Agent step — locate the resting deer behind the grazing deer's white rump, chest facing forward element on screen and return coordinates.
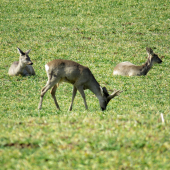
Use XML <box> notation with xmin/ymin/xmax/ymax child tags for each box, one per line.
<box><xmin>8</xmin><ymin>48</ymin><xmax>35</xmax><ymax>76</ymax></box>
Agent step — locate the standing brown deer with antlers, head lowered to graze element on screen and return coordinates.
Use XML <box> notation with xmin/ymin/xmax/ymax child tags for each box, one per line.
<box><xmin>38</xmin><ymin>59</ymin><xmax>122</xmax><ymax>111</ymax></box>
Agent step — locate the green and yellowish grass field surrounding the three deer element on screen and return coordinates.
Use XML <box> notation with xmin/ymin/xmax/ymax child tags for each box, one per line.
<box><xmin>0</xmin><ymin>0</ymin><xmax>170</xmax><ymax>170</ymax></box>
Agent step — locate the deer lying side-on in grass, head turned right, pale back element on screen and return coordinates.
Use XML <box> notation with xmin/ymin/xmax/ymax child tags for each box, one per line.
<box><xmin>113</xmin><ymin>48</ymin><xmax>162</xmax><ymax>76</ymax></box>
